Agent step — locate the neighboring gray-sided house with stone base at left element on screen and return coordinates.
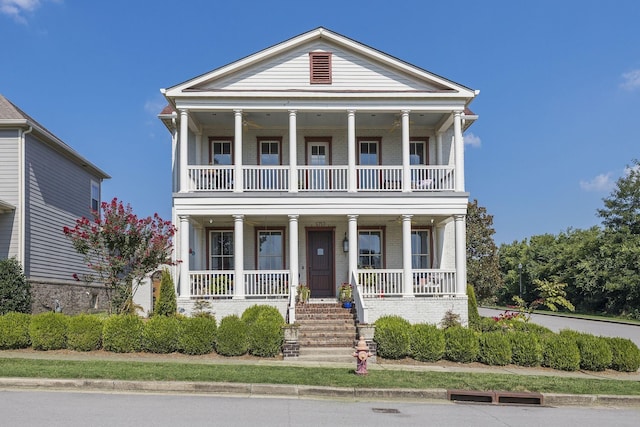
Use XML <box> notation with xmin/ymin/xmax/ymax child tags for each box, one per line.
<box><xmin>0</xmin><ymin>95</ymin><xmax>110</xmax><ymax>312</ymax></box>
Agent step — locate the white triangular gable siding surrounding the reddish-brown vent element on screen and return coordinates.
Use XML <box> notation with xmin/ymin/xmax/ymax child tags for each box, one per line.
<box><xmin>203</xmin><ymin>41</ymin><xmax>439</xmax><ymax>91</ymax></box>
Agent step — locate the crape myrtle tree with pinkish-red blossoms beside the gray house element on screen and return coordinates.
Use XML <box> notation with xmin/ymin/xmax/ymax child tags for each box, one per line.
<box><xmin>63</xmin><ymin>198</ymin><xmax>175</xmax><ymax>313</ymax></box>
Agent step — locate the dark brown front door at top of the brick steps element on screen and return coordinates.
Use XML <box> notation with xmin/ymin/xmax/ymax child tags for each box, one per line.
<box><xmin>307</xmin><ymin>230</ymin><xmax>336</xmax><ymax>298</ymax></box>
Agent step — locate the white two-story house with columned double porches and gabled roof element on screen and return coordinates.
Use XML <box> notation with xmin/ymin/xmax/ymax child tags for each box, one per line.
<box><xmin>159</xmin><ymin>28</ymin><xmax>478</xmax><ymax>323</ymax></box>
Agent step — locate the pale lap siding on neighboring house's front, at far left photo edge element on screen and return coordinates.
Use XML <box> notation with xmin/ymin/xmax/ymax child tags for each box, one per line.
<box><xmin>0</xmin><ymin>135</ymin><xmax>19</xmax><ymax>259</ymax></box>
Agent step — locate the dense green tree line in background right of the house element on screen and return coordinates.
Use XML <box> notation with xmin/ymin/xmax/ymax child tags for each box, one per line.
<box><xmin>467</xmin><ymin>160</ymin><xmax>640</xmax><ymax>319</ymax></box>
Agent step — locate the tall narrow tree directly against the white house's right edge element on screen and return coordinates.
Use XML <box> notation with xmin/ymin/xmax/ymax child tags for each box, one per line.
<box><xmin>466</xmin><ymin>200</ymin><xmax>503</xmax><ymax>302</ymax></box>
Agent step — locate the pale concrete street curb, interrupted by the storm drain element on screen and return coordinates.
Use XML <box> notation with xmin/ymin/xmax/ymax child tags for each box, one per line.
<box><xmin>0</xmin><ymin>378</ymin><xmax>640</xmax><ymax>407</ymax></box>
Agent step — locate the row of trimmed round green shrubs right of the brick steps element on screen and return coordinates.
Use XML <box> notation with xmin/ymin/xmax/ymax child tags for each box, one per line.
<box><xmin>374</xmin><ymin>316</ymin><xmax>640</xmax><ymax>372</ymax></box>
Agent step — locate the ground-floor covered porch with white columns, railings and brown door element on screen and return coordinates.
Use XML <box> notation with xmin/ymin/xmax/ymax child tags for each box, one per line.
<box><xmin>172</xmin><ymin>214</ymin><xmax>466</xmax><ymax>323</ymax></box>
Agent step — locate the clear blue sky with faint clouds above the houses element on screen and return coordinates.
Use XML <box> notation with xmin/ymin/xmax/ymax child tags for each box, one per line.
<box><xmin>0</xmin><ymin>0</ymin><xmax>640</xmax><ymax>244</ymax></box>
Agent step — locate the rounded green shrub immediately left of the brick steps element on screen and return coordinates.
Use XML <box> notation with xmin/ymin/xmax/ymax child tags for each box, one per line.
<box><xmin>242</xmin><ymin>305</ymin><xmax>284</xmax><ymax>357</ymax></box>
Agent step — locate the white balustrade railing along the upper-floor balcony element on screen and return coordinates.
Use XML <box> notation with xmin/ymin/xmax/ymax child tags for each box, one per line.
<box><xmin>188</xmin><ymin>165</ymin><xmax>455</xmax><ymax>192</ymax></box>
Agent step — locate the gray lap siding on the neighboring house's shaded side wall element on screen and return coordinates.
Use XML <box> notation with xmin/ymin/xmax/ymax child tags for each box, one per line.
<box><xmin>25</xmin><ymin>138</ymin><xmax>99</xmax><ymax>280</ymax></box>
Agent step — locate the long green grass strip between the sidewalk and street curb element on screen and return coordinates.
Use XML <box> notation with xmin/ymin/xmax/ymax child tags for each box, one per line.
<box><xmin>0</xmin><ymin>358</ymin><xmax>640</xmax><ymax>395</ymax></box>
